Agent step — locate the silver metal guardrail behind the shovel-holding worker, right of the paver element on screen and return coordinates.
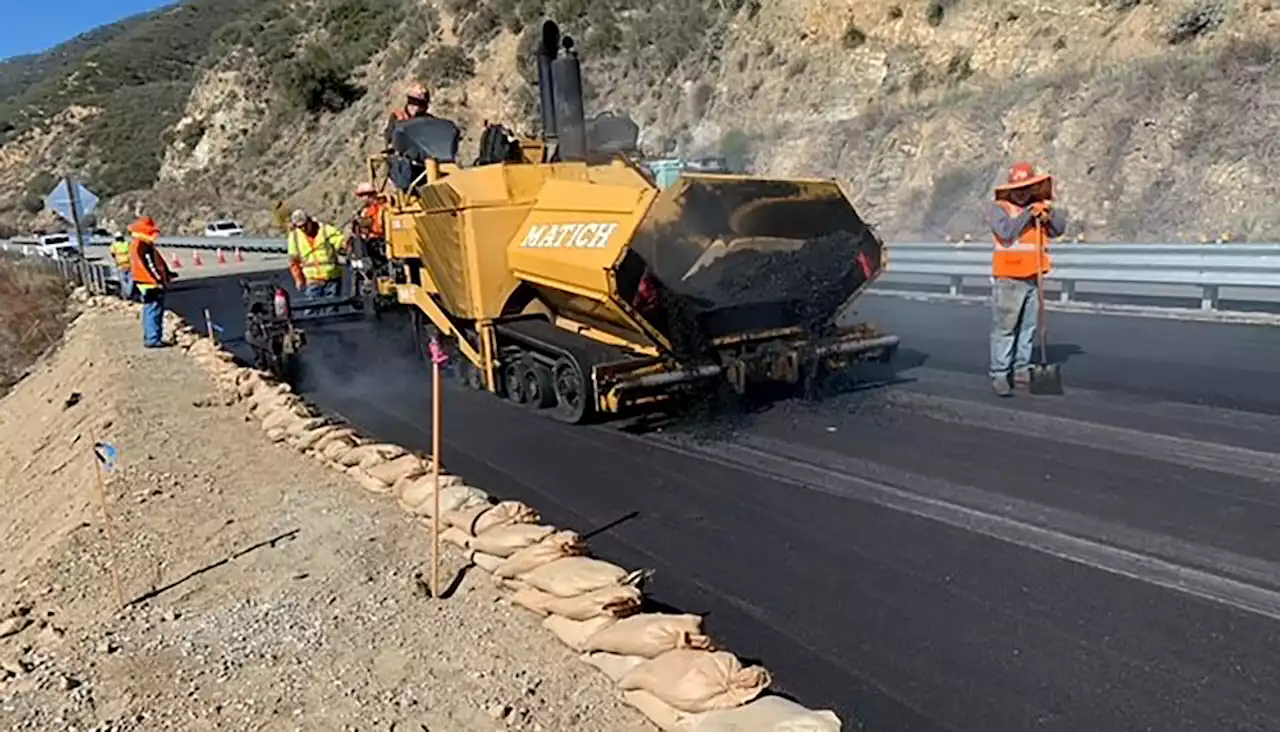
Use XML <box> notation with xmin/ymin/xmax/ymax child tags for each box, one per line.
<box><xmin>886</xmin><ymin>243</ymin><xmax>1280</xmax><ymax>310</ymax></box>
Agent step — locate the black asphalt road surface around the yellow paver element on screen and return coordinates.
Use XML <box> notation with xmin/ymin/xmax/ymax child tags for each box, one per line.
<box><xmin>167</xmin><ymin>280</ymin><xmax>1280</xmax><ymax>732</ymax></box>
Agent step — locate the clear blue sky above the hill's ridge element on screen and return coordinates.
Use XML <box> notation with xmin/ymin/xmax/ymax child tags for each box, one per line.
<box><xmin>0</xmin><ymin>0</ymin><xmax>174</xmax><ymax>59</ymax></box>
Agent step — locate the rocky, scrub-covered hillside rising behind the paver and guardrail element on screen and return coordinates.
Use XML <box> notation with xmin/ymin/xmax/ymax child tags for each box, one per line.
<box><xmin>0</xmin><ymin>0</ymin><xmax>1280</xmax><ymax>241</ymax></box>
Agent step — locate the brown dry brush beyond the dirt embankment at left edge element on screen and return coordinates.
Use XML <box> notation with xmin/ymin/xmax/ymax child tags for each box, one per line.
<box><xmin>0</xmin><ymin>257</ymin><xmax>67</xmax><ymax>394</ymax></box>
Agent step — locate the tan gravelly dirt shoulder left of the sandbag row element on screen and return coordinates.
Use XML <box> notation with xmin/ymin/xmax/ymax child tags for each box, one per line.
<box><xmin>0</xmin><ymin>303</ymin><xmax>652</xmax><ymax>732</ymax></box>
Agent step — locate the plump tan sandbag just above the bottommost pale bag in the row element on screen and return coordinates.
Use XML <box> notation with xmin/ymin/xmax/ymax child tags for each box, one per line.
<box><xmin>618</xmin><ymin>649</ymin><xmax>773</xmax><ymax>713</ymax></box>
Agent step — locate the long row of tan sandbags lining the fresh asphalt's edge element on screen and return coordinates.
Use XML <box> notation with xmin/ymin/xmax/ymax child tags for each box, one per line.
<box><xmin>154</xmin><ymin>309</ymin><xmax>841</xmax><ymax>732</ymax></box>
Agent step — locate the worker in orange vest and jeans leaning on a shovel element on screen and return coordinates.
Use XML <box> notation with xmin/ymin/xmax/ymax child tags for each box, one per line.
<box><xmin>989</xmin><ymin>163</ymin><xmax>1066</xmax><ymax>397</ymax></box>
